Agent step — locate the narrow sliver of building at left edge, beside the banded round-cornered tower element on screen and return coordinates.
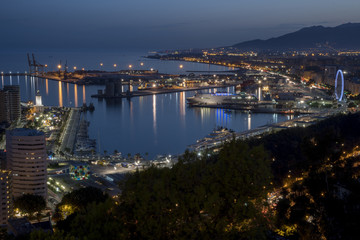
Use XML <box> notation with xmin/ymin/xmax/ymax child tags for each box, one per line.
<box><xmin>0</xmin><ymin>170</ymin><xmax>12</xmax><ymax>226</ymax></box>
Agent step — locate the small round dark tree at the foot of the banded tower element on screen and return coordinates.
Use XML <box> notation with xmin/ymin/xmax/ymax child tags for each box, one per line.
<box><xmin>14</xmin><ymin>194</ymin><xmax>46</xmax><ymax>218</ymax></box>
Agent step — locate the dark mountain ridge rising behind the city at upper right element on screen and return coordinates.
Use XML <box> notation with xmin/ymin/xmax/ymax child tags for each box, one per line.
<box><xmin>232</xmin><ymin>23</ymin><xmax>360</xmax><ymax>50</ymax></box>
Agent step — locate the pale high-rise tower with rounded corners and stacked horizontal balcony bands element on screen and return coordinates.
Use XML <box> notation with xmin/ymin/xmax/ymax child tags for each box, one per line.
<box><xmin>6</xmin><ymin>128</ymin><xmax>47</xmax><ymax>199</ymax></box>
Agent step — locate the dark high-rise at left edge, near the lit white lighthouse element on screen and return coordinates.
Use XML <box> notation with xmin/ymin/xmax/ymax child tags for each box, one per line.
<box><xmin>0</xmin><ymin>85</ymin><xmax>21</xmax><ymax>123</ymax></box>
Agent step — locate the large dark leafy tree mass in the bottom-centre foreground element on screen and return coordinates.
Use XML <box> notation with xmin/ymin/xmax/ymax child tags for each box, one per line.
<box><xmin>120</xmin><ymin>141</ymin><xmax>271</xmax><ymax>239</ymax></box>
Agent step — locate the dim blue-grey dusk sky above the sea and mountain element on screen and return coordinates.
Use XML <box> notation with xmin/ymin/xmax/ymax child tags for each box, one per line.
<box><xmin>0</xmin><ymin>0</ymin><xmax>360</xmax><ymax>50</ymax></box>
